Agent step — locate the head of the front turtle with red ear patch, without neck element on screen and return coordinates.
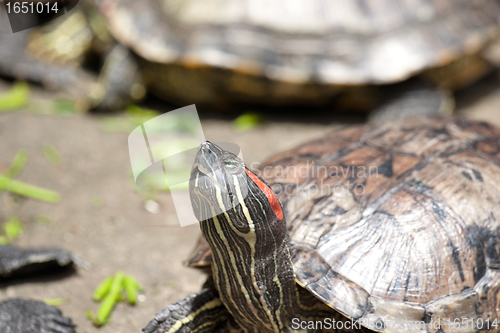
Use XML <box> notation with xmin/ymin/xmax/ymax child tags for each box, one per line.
<box><xmin>190</xmin><ymin>141</ymin><xmax>286</xmax><ymax>228</ymax></box>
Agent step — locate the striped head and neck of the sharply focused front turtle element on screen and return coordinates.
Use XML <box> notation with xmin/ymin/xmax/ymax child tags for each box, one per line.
<box><xmin>190</xmin><ymin>142</ymin><xmax>296</xmax><ymax>332</ymax></box>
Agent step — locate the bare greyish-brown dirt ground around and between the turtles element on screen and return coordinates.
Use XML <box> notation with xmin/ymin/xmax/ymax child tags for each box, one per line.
<box><xmin>0</xmin><ymin>73</ymin><xmax>500</xmax><ymax>333</ymax></box>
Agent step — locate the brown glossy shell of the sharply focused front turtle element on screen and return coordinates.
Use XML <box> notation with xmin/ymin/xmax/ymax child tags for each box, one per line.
<box><xmin>189</xmin><ymin>118</ymin><xmax>500</xmax><ymax>332</ymax></box>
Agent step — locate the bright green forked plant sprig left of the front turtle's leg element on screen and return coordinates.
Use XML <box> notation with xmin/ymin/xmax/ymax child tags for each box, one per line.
<box><xmin>87</xmin><ymin>271</ymin><xmax>142</xmax><ymax>327</ymax></box>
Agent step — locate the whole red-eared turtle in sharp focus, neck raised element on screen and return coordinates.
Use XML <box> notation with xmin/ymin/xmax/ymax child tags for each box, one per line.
<box><xmin>143</xmin><ymin>118</ymin><xmax>500</xmax><ymax>333</ymax></box>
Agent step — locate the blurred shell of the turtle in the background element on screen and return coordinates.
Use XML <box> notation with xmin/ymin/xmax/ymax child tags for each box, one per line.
<box><xmin>101</xmin><ymin>0</ymin><xmax>500</xmax><ymax>103</ymax></box>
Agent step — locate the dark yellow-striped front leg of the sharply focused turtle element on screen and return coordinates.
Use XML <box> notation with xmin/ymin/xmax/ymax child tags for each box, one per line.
<box><xmin>142</xmin><ymin>288</ymin><xmax>242</xmax><ymax>333</ymax></box>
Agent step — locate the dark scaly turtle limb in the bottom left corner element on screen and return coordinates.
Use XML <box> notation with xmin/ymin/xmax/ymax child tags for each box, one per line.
<box><xmin>0</xmin><ymin>298</ymin><xmax>76</xmax><ymax>333</ymax></box>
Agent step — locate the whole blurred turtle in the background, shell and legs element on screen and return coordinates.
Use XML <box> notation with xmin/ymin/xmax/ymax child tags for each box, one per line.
<box><xmin>0</xmin><ymin>0</ymin><xmax>500</xmax><ymax>118</ymax></box>
